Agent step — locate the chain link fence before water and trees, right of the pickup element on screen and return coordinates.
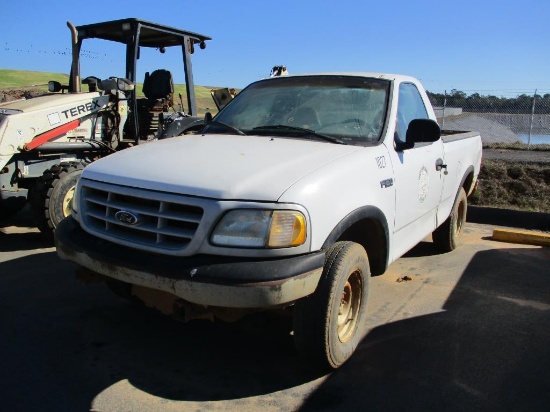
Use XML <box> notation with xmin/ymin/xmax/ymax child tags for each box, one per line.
<box><xmin>428</xmin><ymin>90</ymin><xmax>550</xmax><ymax>149</ymax></box>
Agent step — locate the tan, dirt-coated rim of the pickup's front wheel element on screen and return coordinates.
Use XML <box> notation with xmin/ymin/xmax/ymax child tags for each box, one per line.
<box><xmin>338</xmin><ymin>270</ymin><xmax>362</xmax><ymax>342</ymax></box>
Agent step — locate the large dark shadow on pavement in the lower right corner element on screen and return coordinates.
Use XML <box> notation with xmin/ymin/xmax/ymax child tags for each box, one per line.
<box><xmin>302</xmin><ymin>248</ymin><xmax>550</xmax><ymax>411</ymax></box>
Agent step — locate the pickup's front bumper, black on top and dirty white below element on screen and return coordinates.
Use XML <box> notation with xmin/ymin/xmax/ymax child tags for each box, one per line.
<box><xmin>55</xmin><ymin>217</ymin><xmax>325</xmax><ymax>308</ymax></box>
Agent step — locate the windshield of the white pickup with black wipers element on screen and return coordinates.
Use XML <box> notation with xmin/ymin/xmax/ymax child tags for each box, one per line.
<box><xmin>211</xmin><ymin>75</ymin><xmax>390</xmax><ymax>144</ymax></box>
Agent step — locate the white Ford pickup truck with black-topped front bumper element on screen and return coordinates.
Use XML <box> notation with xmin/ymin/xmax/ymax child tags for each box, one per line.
<box><xmin>56</xmin><ymin>73</ymin><xmax>481</xmax><ymax>368</ymax></box>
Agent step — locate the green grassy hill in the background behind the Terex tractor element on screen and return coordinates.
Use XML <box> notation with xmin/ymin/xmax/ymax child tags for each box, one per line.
<box><xmin>0</xmin><ymin>69</ymin><xmax>222</xmax><ymax>115</ymax></box>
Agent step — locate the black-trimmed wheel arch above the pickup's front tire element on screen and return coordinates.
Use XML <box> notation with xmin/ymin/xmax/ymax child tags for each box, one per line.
<box><xmin>323</xmin><ymin>206</ymin><xmax>389</xmax><ymax>276</ymax></box>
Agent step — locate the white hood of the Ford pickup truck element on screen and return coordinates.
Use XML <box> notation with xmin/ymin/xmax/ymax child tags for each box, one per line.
<box><xmin>82</xmin><ymin>135</ymin><xmax>361</xmax><ymax>201</ymax></box>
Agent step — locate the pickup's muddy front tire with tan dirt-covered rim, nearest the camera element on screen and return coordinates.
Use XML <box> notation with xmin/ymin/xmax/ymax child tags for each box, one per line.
<box><xmin>294</xmin><ymin>242</ymin><xmax>370</xmax><ymax>369</ymax></box>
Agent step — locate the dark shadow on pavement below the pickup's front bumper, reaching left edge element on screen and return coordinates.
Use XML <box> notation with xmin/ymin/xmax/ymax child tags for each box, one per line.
<box><xmin>0</xmin><ymin>248</ymin><xmax>317</xmax><ymax>411</ymax></box>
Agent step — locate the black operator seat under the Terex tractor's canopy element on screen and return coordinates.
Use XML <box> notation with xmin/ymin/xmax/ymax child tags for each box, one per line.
<box><xmin>137</xmin><ymin>69</ymin><xmax>174</xmax><ymax>139</ymax></box>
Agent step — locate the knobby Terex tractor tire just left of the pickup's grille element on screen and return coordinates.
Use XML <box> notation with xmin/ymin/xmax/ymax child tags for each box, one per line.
<box><xmin>31</xmin><ymin>161</ymin><xmax>86</xmax><ymax>239</ymax></box>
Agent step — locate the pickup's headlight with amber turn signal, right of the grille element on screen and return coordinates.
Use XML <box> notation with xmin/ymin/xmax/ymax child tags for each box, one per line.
<box><xmin>211</xmin><ymin>209</ymin><xmax>306</xmax><ymax>248</ymax></box>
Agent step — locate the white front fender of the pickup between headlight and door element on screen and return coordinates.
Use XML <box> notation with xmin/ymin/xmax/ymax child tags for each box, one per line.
<box><xmin>279</xmin><ymin>145</ymin><xmax>395</xmax><ymax>266</ymax></box>
